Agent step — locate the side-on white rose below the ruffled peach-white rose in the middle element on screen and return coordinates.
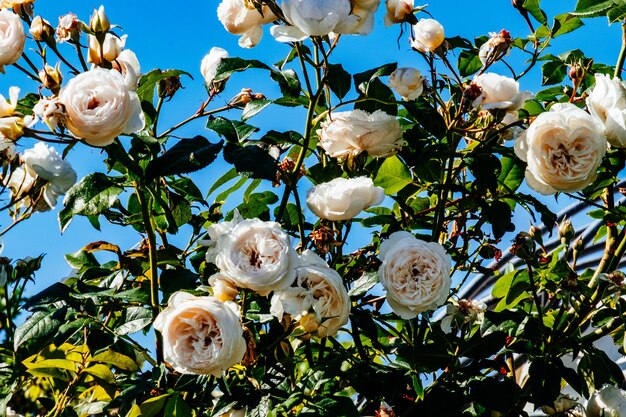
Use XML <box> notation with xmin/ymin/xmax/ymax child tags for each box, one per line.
<box><xmin>306</xmin><ymin>177</ymin><xmax>385</xmax><ymax>221</ymax></box>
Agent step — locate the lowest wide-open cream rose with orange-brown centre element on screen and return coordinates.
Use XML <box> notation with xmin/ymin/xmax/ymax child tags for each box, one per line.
<box><xmin>154</xmin><ymin>291</ymin><xmax>247</xmax><ymax>377</ymax></box>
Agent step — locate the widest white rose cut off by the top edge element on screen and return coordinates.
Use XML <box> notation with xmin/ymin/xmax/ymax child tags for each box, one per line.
<box><xmin>270</xmin><ymin>0</ymin><xmax>372</xmax><ymax>42</ymax></box>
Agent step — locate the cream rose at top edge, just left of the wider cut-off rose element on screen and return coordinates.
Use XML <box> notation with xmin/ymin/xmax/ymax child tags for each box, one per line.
<box><xmin>217</xmin><ymin>0</ymin><xmax>276</xmax><ymax>48</ymax></box>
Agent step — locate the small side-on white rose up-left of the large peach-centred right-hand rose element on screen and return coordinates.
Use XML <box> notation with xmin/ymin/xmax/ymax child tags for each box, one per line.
<box><xmin>472</xmin><ymin>73</ymin><xmax>532</xmax><ymax>111</ymax></box>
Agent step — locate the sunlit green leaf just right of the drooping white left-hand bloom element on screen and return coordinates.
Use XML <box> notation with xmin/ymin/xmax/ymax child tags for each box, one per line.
<box><xmin>59</xmin><ymin>172</ymin><xmax>124</xmax><ymax>232</ymax></box>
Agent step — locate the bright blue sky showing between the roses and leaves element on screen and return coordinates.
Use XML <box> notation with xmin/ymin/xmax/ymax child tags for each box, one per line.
<box><xmin>0</xmin><ymin>0</ymin><xmax>621</xmax><ymax>292</ymax></box>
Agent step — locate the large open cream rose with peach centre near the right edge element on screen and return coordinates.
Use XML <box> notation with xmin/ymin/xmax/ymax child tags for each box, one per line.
<box><xmin>515</xmin><ymin>103</ymin><xmax>607</xmax><ymax>195</ymax></box>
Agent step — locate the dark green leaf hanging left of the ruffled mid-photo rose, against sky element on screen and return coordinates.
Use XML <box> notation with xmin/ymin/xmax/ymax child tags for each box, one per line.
<box><xmin>224</xmin><ymin>142</ymin><xmax>278</xmax><ymax>181</ymax></box>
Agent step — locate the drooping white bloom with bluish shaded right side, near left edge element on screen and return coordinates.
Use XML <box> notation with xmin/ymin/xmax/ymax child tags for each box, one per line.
<box><xmin>22</xmin><ymin>142</ymin><xmax>76</xmax><ymax>208</ymax></box>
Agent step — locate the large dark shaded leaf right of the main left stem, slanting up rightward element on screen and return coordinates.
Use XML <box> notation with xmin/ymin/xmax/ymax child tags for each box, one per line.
<box><xmin>146</xmin><ymin>135</ymin><xmax>224</xmax><ymax>179</ymax></box>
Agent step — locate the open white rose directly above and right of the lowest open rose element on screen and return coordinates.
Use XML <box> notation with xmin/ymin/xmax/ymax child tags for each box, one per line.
<box><xmin>207</xmin><ymin>219</ymin><xmax>298</xmax><ymax>295</ymax></box>
